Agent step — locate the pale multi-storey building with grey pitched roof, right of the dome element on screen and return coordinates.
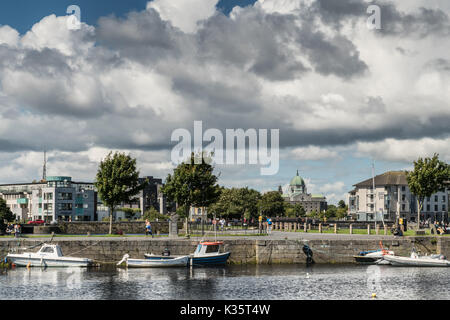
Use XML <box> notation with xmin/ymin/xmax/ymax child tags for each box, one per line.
<box><xmin>347</xmin><ymin>171</ymin><xmax>449</xmax><ymax>222</ymax></box>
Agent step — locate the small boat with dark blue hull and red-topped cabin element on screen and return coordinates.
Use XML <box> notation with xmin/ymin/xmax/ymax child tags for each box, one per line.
<box><xmin>191</xmin><ymin>241</ymin><xmax>230</xmax><ymax>266</ymax></box>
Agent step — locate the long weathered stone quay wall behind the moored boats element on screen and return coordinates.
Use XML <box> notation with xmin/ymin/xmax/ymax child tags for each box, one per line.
<box><xmin>0</xmin><ymin>237</ymin><xmax>450</xmax><ymax>264</ymax></box>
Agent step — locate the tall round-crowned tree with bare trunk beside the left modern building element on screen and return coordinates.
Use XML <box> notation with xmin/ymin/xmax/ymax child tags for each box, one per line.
<box><xmin>94</xmin><ymin>152</ymin><xmax>147</xmax><ymax>234</ymax></box>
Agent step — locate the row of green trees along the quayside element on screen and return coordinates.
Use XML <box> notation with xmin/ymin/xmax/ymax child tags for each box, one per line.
<box><xmin>95</xmin><ymin>153</ymin><xmax>450</xmax><ymax>232</ymax></box>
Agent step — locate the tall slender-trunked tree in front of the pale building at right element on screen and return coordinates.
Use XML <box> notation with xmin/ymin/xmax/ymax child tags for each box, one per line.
<box><xmin>406</xmin><ymin>153</ymin><xmax>450</xmax><ymax>229</ymax></box>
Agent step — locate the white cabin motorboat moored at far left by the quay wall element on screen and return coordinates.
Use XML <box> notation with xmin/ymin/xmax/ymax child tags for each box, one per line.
<box><xmin>6</xmin><ymin>244</ymin><xmax>93</xmax><ymax>267</ymax></box>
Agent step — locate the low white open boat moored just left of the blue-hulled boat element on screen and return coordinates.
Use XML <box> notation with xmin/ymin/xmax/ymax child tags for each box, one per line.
<box><xmin>117</xmin><ymin>254</ymin><xmax>189</xmax><ymax>268</ymax></box>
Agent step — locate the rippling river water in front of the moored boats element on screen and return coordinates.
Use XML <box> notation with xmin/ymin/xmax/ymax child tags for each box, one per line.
<box><xmin>0</xmin><ymin>265</ymin><xmax>450</xmax><ymax>300</ymax></box>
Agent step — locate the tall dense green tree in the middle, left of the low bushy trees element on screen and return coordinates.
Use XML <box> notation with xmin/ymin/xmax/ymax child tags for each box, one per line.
<box><xmin>162</xmin><ymin>153</ymin><xmax>220</xmax><ymax>217</ymax></box>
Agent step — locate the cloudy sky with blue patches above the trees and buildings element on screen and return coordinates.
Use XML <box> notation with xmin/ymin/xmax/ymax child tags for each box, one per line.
<box><xmin>0</xmin><ymin>0</ymin><xmax>450</xmax><ymax>203</ymax></box>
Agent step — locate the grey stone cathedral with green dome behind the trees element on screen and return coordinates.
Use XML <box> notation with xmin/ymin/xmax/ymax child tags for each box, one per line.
<box><xmin>280</xmin><ymin>171</ymin><xmax>328</xmax><ymax>214</ymax></box>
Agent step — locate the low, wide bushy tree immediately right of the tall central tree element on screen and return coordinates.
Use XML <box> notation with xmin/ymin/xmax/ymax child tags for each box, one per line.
<box><xmin>209</xmin><ymin>188</ymin><xmax>261</xmax><ymax>219</ymax></box>
